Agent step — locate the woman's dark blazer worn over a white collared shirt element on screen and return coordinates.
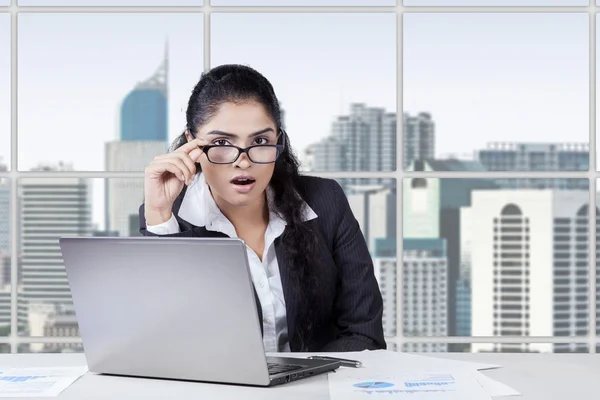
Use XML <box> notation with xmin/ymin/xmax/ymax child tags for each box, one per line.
<box><xmin>139</xmin><ymin>176</ymin><xmax>386</xmax><ymax>352</ymax></box>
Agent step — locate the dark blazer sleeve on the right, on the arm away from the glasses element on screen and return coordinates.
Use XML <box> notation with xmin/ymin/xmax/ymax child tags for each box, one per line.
<box><xmin>322</xmin><ymin>181</ymin><xmax>387</xmax><ymax>352</ymax></box>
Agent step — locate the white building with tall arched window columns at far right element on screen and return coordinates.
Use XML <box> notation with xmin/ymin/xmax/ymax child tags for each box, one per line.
<box><xmin>462</xmin><ymin>190</ymin><xmax>589</xmax><ymax>352</ymax></box>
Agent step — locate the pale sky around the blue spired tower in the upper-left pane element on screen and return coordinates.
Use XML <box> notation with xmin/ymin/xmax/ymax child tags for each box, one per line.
<box><xmin>19</xmin><ymin>13</ymin><xmax>204</xmax><ymax>170</ymax></box>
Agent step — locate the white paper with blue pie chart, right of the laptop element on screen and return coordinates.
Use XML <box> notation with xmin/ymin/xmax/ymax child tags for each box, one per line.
<box><xmin>328</xmin><ymin>369</ymin><xmax>491</xmax><ymax>400</ymax></box>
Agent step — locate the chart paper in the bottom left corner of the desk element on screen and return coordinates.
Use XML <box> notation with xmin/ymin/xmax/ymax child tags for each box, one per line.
<box><xmin>0</xmin><ymin>367</ymin><xmax>88</xmax><ymax>398</ymax></box>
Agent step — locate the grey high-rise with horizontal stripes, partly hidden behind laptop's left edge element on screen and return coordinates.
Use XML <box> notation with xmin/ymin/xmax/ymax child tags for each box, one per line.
<box><xmin>19</xmin><ymin>165</ymin><xmax>91</xmax><ymax>310</ymax></box>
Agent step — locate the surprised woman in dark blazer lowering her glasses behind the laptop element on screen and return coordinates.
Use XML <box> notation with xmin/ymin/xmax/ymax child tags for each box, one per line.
<box><xmin>139</xmin><ymin>65</ymin><xmax>386</xmax><ymax>352</ymax></box>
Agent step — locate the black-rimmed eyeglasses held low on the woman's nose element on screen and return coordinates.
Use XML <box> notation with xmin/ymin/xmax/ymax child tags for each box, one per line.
<box><xmin>198</xmin><ymin>130</ymin><xmax>285</xmax><ymax>164</ymax></box>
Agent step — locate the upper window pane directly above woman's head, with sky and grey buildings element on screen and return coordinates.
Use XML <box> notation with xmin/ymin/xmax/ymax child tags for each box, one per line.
<box><xmin>211</xmin><ymin>13</ymin><xmax>396</xmax><ymax>172</ymax></box>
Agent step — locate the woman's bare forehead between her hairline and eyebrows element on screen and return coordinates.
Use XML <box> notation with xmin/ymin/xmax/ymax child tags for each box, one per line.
<box><xmin>200</xmin><ymin>102</ymin><xmax>275</xmax><ymax>136</ymax></box>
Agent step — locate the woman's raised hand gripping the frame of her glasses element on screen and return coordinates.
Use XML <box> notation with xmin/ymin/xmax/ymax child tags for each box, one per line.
<box><xmin>144</xmin><ymin>138</ymin><xmax>208</xmax><ymax>225</ymax></box>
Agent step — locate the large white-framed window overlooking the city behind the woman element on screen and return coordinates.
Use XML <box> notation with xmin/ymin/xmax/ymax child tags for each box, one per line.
<box><xmin>0</xmin><ymin>0</ymin><xmax>600</xmax><ymax>353</ymax></box>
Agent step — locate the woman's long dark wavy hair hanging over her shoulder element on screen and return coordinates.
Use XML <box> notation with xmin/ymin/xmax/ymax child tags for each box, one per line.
<box><xmin>171</xmin><ymin>64</ymin><xmax>318</xmax><ymax>351</ymax></box>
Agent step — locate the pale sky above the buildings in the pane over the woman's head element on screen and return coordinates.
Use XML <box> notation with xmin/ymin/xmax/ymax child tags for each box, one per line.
<box><xmin>210</xmin><ymin>13</ymin><xmax>397</xmax><ymax>155</ymax></box>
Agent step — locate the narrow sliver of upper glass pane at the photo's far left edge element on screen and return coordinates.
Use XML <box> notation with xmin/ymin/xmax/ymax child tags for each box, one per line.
<box><xmin>0</xmin><ymin>14</ymin><xmax>12</xmax><ymax>171</ymax></box>
